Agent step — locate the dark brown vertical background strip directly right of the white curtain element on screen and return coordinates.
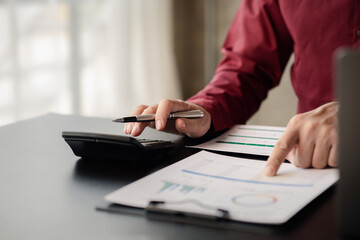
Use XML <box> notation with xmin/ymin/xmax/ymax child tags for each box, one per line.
<box><xmin>173</xmin><ymin>0</ymin><xmax>205</xmax><ymax>99</ymax></box>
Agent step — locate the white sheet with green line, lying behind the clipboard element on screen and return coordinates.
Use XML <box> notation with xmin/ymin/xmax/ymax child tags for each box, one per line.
<box><xmin>188</xmin><ymin>125</ymin><xmax>285</xmax><ymax>156</ymax></box>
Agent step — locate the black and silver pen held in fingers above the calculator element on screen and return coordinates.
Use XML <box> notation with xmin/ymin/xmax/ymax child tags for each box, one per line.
<box><xmin>113</xmin><ymin>110</ymin><xmax>204</xmax><ymax>123</ymax></box>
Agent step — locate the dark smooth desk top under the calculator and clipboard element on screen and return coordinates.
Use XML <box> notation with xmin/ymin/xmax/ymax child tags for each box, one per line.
<box><xmin>0</xmin><ymin>114</ymin><xmax>337</xmax><ymax>240</ymax></box>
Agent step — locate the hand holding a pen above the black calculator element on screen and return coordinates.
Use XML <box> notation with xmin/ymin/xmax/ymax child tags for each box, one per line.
<box><xmin>124</xmin><ymin>99</ymin><xmax>211</xmax><ymax>138</ymax></box>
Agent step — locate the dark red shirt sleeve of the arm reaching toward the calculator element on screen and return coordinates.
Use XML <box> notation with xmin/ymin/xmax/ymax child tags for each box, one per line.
<box><xmin>188</xmin><ymin>0</ymin><xmax>293</xmax><ymax>131</ymax></box>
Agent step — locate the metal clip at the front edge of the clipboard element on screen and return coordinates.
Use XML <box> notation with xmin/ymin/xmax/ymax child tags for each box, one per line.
<box><xmin>145</xmin><ymin>199</ymin><xmax>230</xmax><ymax>221</ymax></box>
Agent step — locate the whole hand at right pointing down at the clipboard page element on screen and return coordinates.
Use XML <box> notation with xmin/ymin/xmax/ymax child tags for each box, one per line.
<box><xmin>264</xmin><ymin>102</ymin><xmax>339</xmax><ymax>176</ymax></box>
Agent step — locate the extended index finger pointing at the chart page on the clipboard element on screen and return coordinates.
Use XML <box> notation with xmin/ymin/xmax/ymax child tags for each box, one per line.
<box><xmin>264</xmin><ymin>127</ymin><xmax>299</xmax><ymax>177</ymax></box>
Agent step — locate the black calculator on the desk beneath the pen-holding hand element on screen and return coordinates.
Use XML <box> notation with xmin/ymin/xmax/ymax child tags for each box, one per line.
<box><xmin>62</xmin><ymin>131</ymin><xmax>175</xmax><ymax>159</ymax></box>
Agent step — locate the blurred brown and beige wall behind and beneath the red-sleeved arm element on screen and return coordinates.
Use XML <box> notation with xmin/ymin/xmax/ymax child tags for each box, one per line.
<box><xmin>173</xmin><ymin>0</ymin><xmax>297</xmax><ymax>126</ymax></box>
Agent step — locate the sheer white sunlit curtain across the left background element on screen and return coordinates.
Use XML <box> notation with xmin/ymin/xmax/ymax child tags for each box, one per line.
<box><xmin>0</xmin><ymin>0</ymin><xmax>181</xmax><ymax>124</ymax></box>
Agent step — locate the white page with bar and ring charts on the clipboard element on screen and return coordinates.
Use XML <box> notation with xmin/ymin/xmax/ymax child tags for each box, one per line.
<box><xmin>105</xmin><ymin>151</ymin><xmax>338</xmax><ymax>224</ymax></box>
